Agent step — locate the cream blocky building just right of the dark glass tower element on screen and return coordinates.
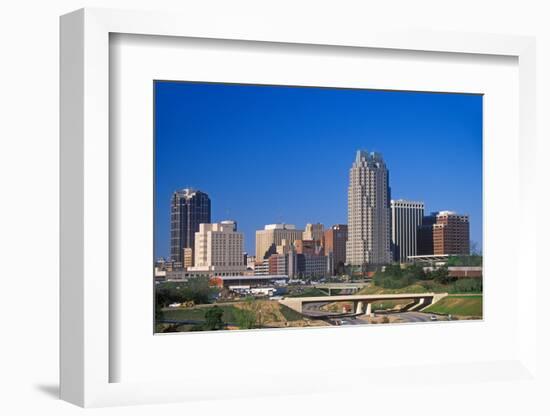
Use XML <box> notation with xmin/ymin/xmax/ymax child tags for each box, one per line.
<box><xmin>188</xmin><ymin>221</ymin><xmax>246</xmax><ymax>276</ymax></box>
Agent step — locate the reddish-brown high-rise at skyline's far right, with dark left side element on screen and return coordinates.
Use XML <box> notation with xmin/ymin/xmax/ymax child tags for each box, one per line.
<box><xmin>418</xmin><ymin>211</ymin><xmax>470</xmax><ymax>256</ymax></box>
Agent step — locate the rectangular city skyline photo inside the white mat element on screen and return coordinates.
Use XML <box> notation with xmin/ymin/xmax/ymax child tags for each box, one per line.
<box><xmin>153</xmin><ymin>80</ymin><xmax>483</xmax><ymax>333</ymax></box>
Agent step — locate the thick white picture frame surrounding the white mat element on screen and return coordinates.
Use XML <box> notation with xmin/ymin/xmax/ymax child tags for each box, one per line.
<box><xmin>60</xmin><ymin>9</ymin><xmax>540</xmax><ymax>407</ymax></box>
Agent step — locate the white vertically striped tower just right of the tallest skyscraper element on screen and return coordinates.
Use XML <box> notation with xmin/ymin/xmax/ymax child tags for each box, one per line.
<box><xmin>391</xmin><ymin>199</ymin><xmax>424</xmax><ymax>263</ymax></box>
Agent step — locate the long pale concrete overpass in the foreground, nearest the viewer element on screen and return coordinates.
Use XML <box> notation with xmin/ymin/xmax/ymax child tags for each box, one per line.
<box><xmin>279</xmin><ymin>293</ymin><xmax>447</xmax><ymax>316</ymax></box>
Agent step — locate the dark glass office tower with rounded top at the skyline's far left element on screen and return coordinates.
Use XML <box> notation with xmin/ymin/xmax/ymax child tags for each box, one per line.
<box><xmin>170</xmin><ymin>188</ymin><xmax>210</xmax><ymax>263</ymax></box>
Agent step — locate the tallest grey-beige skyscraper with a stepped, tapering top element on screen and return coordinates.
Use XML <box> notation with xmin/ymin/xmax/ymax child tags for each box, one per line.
<box><xmin>346</xmin><ymin>150</ymin><xmax>391</xmax><ymax>271</ymax></box>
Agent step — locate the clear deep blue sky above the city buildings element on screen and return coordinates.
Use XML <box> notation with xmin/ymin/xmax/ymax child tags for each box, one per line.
<box><xmin>154</xmin><ymin>82</ymin><xmax>482</xmax><ymax>258</ymax></box>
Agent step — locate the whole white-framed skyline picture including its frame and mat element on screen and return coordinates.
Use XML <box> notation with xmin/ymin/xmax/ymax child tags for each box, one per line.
<box><xmin>61</xmin><ymin>9</ymin><xmax>540</xmax><ymax>409</ymax></box>
